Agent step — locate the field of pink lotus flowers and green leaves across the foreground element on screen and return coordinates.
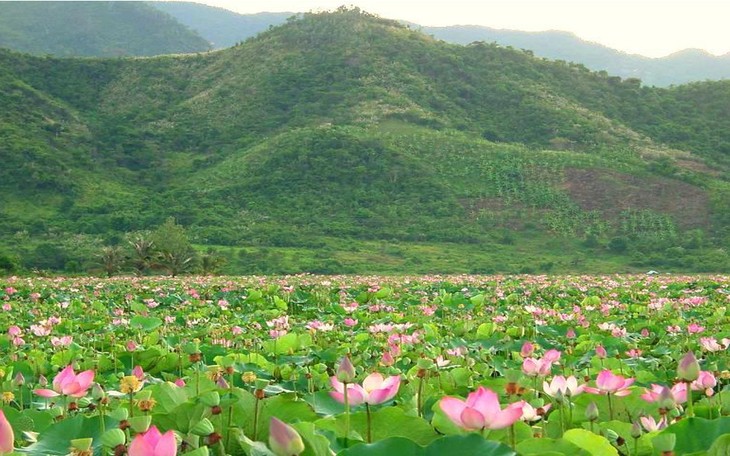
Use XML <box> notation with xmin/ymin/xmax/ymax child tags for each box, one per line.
<box><xmin>0</xmin><ymin>275</ymin><xmax>730</xmax><ymax>456</ymax></box>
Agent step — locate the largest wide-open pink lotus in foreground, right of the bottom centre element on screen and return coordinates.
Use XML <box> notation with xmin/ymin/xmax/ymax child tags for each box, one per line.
<box><xmin>439</xmin><ymin>386</ymin><xmax>525</xmax><ymax>431</ymax></box>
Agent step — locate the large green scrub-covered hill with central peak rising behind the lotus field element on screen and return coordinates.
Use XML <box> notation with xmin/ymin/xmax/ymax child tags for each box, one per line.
<box><xmin>0</xmin><ymin>9</ymin><xmax>730</xmax><ymax>273</ymax></box>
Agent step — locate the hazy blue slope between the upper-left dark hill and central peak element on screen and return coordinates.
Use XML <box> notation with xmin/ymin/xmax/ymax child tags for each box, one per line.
<box><xmin>149</xmin><ymin>2</ymin><xmax>295</xmax><ymax>49</ymax></box>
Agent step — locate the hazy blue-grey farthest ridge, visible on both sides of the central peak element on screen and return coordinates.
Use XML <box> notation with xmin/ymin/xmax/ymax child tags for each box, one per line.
<box><xmin>150</xmin><ymin>2</ymin><xmax>730</xmax><ymax>87</ymax></box>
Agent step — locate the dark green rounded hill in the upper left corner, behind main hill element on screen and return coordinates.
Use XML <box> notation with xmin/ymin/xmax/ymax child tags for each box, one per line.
<box><xmin>0</xmin><ymin>1</ymin><xmax>210</xmax><ymax>57</ymax></box>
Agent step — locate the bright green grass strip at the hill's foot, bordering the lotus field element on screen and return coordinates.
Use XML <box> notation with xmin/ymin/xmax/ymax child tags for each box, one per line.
<box><xmin>206</xmin><ymin>232</ymin><xmax>645</xmax><ymax>275</ymax></box>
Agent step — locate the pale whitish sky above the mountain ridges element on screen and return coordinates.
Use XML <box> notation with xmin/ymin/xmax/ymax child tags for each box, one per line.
<box><xmin>175</xmin><ymin>0</ymin><xmax>730</xmax><ymax>57</ymax></box>
